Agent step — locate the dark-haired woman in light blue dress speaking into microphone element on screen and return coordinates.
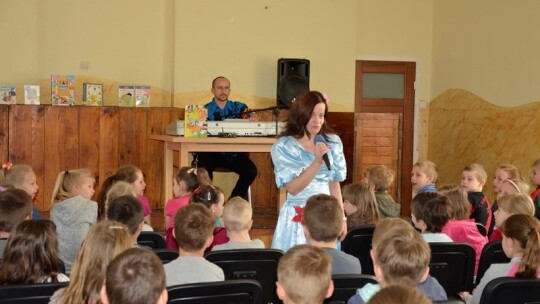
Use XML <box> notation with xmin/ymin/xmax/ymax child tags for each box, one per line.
<box><xmin>271</xmin><ymin>91</ymin><xmax>347</xmax><ymax>251</ymax></box>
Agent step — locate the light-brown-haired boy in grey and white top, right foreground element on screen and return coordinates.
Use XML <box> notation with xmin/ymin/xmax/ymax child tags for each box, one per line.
<box><xmin>347</xmin><ymin>218</ymin><xmax>447</xmax><ymax>304</ymax></box>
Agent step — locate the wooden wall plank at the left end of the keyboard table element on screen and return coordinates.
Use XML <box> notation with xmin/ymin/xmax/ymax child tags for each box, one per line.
<box><xmin>144</xmin><ymin>108</ymin><xmax>165</xmax><ymax>208</ymax></box>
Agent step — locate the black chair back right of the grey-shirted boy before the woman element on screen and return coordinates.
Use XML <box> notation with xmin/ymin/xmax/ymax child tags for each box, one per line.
<box><xmin>341</xmin><ymin>225</ymin><xmax>375</xmax><ymax>275</ymax></box>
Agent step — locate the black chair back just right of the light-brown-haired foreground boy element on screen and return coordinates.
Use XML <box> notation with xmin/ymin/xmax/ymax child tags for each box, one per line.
<box><xmin>429</xmin><ymin>243</ymin><xmax>476</xmax><ymax>298</ymax></box>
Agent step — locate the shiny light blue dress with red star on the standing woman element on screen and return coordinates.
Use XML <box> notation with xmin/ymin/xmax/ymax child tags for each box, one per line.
<box><xmin>271</xmin><ymin>134</ymin><xmax>347</xmax><ymax>251</ymax></box>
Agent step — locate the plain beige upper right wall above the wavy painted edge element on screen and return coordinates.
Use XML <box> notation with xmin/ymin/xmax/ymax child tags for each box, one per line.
<box><xmin>431</xmin><ymin>0</ymin><xmax>540</xmax><ymax>106</ymax></box>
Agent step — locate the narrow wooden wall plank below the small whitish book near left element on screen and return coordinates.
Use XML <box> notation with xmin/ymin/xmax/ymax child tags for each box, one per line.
<box><xmin>31</xmin><ymin>105</ymin><xmax>46</xmax><ymax>211</ymax></box>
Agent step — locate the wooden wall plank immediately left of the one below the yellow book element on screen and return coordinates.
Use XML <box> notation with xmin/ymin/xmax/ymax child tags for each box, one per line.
<box><xmin>63</xmin><ymin>107</ymin><xmax>79</xmax><ymax>170</ymax></box>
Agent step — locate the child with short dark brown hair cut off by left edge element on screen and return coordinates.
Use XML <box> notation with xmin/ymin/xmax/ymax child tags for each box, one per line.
<box><xmin>0</xmin><ymin>189</ymin><xmax>32</xmax><ymax>260</ymax></box>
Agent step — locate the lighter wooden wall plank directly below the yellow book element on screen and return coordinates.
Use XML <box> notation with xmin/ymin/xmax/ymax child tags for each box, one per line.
<box><xmin>78</xmin><ymin>107</ymin><xmax>101</xmax><ymax>177</ymax></box>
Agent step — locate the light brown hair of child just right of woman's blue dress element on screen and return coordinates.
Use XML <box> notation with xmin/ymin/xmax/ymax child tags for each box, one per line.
<box><xmin>343</xmin><ymin>182</ymin><xmax>379</xmax><ymax>223</ymax></box>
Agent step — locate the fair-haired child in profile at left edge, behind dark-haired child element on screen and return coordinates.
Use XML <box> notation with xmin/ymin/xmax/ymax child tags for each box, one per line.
<box><xmin>0</xmin><ymin>162</ymin><xmax>41</xmax><ymax>219</ymax></box>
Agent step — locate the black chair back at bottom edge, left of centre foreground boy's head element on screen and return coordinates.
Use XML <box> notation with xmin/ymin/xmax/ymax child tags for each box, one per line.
<box><xmin>167</xmin><ymin>280</ymin><xmax>263</xmax><ymax>304</ymax></box>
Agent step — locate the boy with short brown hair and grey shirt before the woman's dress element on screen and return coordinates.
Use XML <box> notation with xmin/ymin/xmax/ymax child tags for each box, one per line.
<box><xmin>304</xmin><ymin>194</ymin><xmax>362</xmax><ymax>275</ymax></box>
